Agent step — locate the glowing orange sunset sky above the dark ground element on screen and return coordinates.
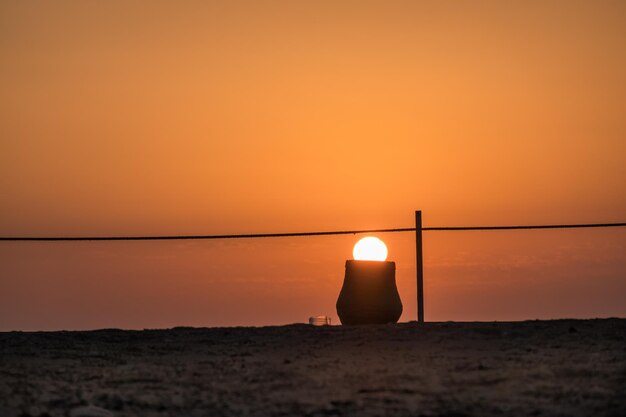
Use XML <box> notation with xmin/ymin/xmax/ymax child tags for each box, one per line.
<box><xmin>0</xmin><ymin>0</ymin><xmax>626</xmax><ymax>330</ymax></box>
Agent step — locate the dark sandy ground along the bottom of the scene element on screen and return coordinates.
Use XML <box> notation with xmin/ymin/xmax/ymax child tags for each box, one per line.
<box><xmin>0</xmin><ymin>319</ymin><xmax>626</xmax><ymax>417</ymax></box>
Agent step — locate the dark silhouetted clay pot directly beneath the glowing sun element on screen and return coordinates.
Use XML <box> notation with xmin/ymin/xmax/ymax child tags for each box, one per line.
<box><xmin>337</xmin><ymin>260</ymin><xmax>402</xmax><ymax>325</ymax></box>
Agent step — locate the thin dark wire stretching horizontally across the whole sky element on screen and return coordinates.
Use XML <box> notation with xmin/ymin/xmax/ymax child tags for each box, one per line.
<box><xmin>0</xmin><ymin>223</ymin><xmax>626</xmax><ymax>242</ymax></box>
